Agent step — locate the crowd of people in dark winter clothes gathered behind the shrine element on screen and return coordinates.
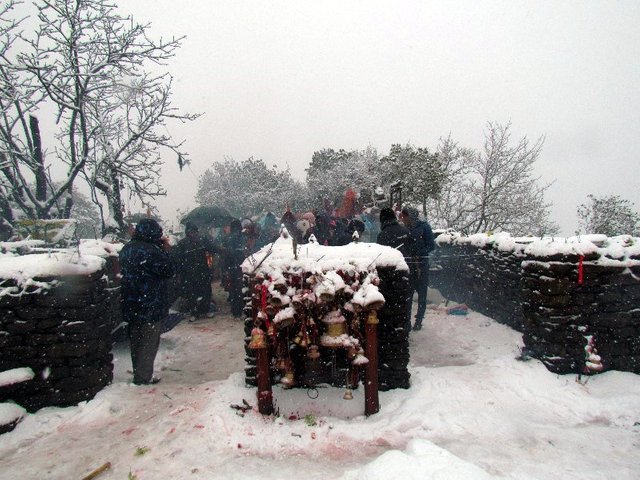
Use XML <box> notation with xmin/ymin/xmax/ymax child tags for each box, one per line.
<box><xmin>120</xmin><ymin>202</ymin><xmax>435</xmax><ymax>384</ymax></box>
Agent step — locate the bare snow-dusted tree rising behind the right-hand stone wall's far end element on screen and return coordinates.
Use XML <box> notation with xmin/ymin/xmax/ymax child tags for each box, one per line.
<box><xmin>431</xmin><ymin>123</ymin><xmax>558</xmax><ymax>235</ymax></box>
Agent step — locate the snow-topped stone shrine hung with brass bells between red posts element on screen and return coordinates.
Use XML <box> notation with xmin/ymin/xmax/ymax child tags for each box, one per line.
<box><xmin>242</xmin><ymin>230</ymin><xmax>411</xmax><ymax>415</ymax></box>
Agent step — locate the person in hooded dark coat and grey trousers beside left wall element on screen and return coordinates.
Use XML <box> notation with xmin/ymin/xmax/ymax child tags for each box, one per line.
<box><xmin>120</xmin><ymin>218</ymin><xmax>176</xmax><ymax>385</ymax></box>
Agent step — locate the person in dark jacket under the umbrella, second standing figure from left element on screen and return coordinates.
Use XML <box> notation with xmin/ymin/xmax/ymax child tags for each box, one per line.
<box><xmin>171</xmin><ymin>223</ymin><xmax>219</xmax><ymax>318</ymax></box>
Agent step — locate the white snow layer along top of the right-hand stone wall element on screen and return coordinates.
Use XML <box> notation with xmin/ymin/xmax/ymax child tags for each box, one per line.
<box><xmin>436</xmin><ymin>231</ymin><xmax>640</xmax><ymax>265</ymax></box>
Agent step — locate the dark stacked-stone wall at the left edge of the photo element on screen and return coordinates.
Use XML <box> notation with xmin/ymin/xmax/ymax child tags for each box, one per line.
<box><xmin>0</xmin><ymin>271</ymin><xmax>120</xmax><ymax>412</ymax></box>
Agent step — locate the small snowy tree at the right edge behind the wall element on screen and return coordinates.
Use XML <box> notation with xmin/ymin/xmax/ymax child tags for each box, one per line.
<box><xmin>576</xmin><ymin>195</ymin><xmax>640</xmax><ymax>236</ymax></box>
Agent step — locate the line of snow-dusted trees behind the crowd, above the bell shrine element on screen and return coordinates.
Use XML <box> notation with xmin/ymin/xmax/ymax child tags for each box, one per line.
<box><xmin>196</xmin><ymin>123</ymin><xmax>558</xmax><ymax>235</ymax></box>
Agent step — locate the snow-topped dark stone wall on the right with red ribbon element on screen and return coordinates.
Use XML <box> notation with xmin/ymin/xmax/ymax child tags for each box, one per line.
<box><xmin>431</xmin><ymin>236</ymin><xmax>640</xmax><ymax>374</ymax></box>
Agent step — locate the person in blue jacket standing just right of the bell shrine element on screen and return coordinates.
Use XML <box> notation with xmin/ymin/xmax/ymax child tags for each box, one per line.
<box><xmin>400</xmin><ymin>207</ymin><xmax>436</xmax><ymax>330</ymax></box>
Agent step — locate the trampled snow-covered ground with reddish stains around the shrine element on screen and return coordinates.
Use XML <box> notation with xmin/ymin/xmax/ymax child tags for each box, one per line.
<box><xmin>0</xmin><ymin>291</ymin><xmax>640</xmax><ymax>480</ymax></box>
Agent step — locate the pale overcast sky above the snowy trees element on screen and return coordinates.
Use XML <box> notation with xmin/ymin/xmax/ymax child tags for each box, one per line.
<box><xmin>119</xmin><ymin>0</ymin><xmax>640</xmax><ymax>235</ymax></box>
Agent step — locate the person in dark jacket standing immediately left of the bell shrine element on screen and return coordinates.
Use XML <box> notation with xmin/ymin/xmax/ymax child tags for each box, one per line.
<box><xmin>221</xmin><ymin>219</ymin><xmax>246</xmax><ymax>318</ymax></box>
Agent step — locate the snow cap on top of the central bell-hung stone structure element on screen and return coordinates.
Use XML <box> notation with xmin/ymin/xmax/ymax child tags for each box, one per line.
<box><xmin>242</xmin><ymin>236</ymin><xmax>409</xmax><ymax>275</ymax></box>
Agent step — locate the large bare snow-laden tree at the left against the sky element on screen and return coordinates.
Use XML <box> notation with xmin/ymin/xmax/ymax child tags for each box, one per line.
<box><xmin>3</xmin><ymin>0</ymin><xmax>197</xmax><ymax>234</ymax></box>
